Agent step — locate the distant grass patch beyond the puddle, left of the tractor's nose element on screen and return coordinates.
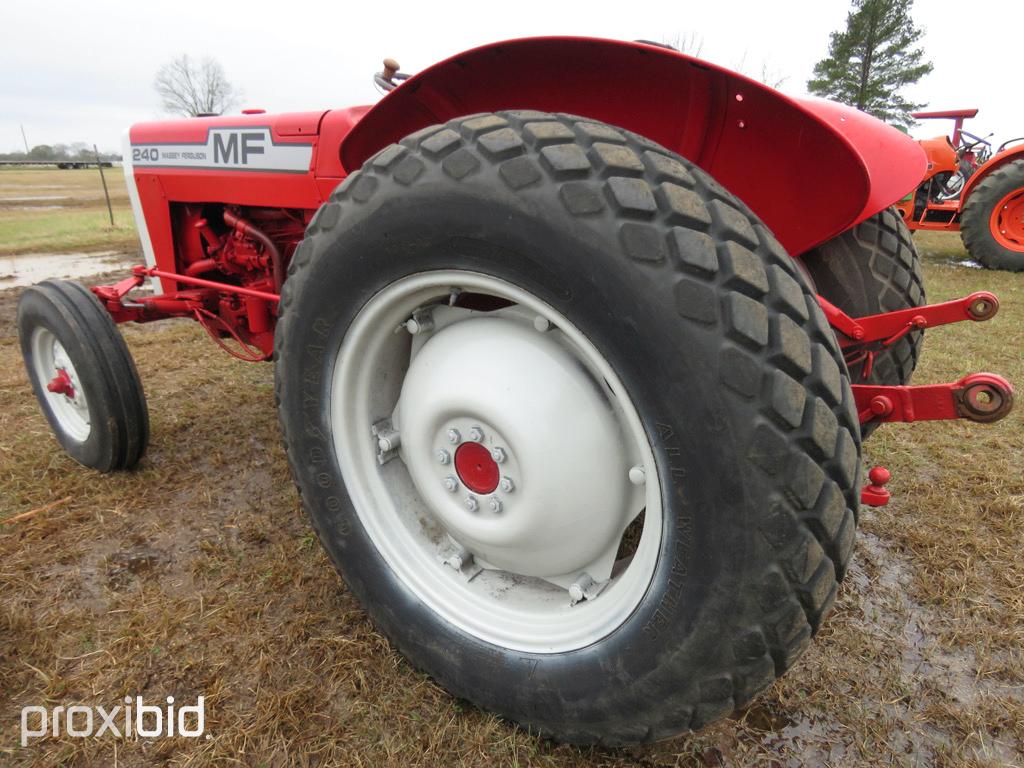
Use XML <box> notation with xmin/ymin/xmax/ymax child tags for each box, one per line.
<box><xmin>0</xmin><ymin>167</ymin><xmax>138</xmax><ymax>256</ymax></box>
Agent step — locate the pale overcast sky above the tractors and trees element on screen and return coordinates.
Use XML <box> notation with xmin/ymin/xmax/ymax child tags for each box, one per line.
<box><xmin>0</xmin><ymin>0</ymin><xmax>1024</xmax><ymax>152</ymax></box>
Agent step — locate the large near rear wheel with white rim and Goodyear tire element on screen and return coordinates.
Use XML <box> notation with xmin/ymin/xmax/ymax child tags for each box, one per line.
<box><xmin>274</xmin><ymin>112</ymin><xmax>860</xmax><ymax>744</ymax></box>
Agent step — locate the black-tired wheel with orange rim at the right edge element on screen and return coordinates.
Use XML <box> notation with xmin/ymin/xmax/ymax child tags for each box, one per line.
<box><xmin>961</xmin><ymin>160</ymin><xmax>1024</xmax><ymax>272</ymax></box>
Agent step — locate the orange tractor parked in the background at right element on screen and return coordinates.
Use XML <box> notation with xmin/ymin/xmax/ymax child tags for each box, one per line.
<box><xmin>897</xmin><ymin>110</ymin><xmax>1024</xmax><ymax>272</ymax></box>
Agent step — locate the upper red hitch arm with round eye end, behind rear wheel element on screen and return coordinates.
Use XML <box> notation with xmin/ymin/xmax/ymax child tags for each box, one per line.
<box><xmin>818</xmin><ymin>291</ymin><xmax>999</xmax><ymax>347</ymax></box>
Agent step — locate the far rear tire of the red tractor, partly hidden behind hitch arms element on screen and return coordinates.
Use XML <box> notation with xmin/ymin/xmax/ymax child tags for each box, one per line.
<box><xmin>801</xmin><ymin>208</ymin><xmax>925</xmax><ymax>431</ymax></box>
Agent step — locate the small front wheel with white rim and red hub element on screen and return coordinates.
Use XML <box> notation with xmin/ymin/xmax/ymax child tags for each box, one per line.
<box><xmin>17</xmin><ymin>280</ymin><xmax>150</xmax><ymax>472</ymax></box>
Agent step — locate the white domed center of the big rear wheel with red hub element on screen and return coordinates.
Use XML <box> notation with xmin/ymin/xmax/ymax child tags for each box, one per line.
<box><xmin>393</xmin><ymin>315</ymin><xmax>638</xmax><ymax>583</ymax></box>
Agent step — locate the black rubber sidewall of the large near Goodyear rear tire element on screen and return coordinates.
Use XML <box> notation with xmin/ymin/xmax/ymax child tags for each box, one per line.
<box><xmin>275</xmin><ymin>114</ymin><xmax>857</xmax><ymax>743</ymax></box>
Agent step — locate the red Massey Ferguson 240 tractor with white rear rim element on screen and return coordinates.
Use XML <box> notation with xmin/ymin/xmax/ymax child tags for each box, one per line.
<box><xmin>18</xmin><ymin>38</ymin><xmax>1020</xmax><ymax>744</ymax></box>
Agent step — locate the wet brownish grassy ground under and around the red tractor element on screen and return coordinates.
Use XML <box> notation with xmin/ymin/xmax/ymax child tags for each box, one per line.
<box><xmin>0</xmin><ymin>165</ymin><xmax>1024</xmax><ymax>768</ymax></box>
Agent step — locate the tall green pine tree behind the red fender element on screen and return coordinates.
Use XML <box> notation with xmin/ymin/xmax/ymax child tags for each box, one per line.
<box><xmin>807</xmin><ymin>0</ymin><xmax>932</xmax><ymax>127</ymax></box>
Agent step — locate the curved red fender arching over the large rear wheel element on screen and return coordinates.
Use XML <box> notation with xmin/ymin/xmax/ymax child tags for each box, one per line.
<box><xmin>340</xmin><ymin>37</ymin><xmax>926</xmax><ymax>254</ymax></box>
